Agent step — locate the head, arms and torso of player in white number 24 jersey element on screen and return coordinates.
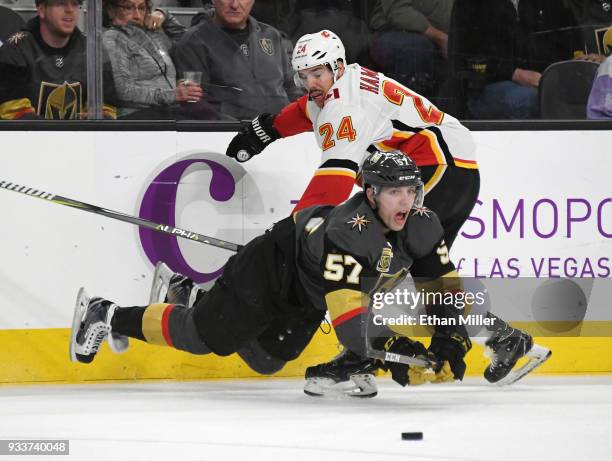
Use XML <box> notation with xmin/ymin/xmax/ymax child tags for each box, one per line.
<box><xmin>227</xmin><ymin>30</ymin><xmax>478</xmax><ymax>217</ymax></box>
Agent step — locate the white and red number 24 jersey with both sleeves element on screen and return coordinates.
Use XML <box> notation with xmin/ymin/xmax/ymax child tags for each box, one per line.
<box><xmin>274</xmin><ymin>64</ymin><xmax>478</xmax><ymax>211</ymax></box>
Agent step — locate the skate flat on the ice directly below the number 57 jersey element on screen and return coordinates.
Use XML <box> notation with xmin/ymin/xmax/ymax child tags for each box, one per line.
<box><xmin>304</xmin><ymin>349</ymin><xmax>378</xmax><ymax>398</ymax></box>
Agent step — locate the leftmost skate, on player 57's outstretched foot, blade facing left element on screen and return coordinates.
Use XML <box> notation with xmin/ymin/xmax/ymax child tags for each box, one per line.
<box><xmin>69</xmin><ymin>288</ymin><xmax>129</xmax><ymax>363</ymax></box>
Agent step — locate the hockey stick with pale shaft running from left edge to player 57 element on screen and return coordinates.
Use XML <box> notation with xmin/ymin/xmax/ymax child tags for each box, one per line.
<box><xmin>0</xmin><ymin>181</ymin><xmax>242</xmax><ymax>251</ymax></box>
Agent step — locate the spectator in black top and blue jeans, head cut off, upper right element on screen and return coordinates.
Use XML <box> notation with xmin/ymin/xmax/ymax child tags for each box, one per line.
<box><xmin>449</xmin><ymin>0</ymin><xmax>542</xmax><ymax>119</ymax></box>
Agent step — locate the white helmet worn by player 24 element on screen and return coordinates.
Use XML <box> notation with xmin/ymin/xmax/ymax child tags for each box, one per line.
<box><xmin>291</xmin><ymin>30</ymin><xmax>346</xmax><ymax>85</ymax></box>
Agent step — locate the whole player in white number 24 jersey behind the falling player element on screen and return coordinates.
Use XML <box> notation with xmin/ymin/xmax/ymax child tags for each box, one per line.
<box><xmin>227</xmin><ymin>30</ymin><xmax>548</xmax><ymax>396</ymax></box>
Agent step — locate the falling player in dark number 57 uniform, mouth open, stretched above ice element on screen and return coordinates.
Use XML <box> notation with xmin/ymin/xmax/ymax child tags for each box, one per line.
<box><xmin>70</xmin><ymin>152</ymin><xmax>482</xmax><ymax>396</ymax></box>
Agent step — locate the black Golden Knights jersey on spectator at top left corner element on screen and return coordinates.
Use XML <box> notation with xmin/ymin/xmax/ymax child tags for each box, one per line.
<box><xmin>0</xmin><ymin>17</ymin><xmax>112</xmax><ymax>120</ymax></box>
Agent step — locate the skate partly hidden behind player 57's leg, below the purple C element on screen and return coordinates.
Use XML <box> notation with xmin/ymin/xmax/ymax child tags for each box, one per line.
<box><xmin>149</xmin><ymin>261</ymin><xmax>203</xmax><ymax>308</ymax></box>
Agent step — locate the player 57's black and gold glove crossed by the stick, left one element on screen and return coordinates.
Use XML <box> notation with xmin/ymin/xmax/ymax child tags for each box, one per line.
<box><xmin>372</xmin><ymin>336</ymin><xmax>438</xmax><ymax>386</ymax></box>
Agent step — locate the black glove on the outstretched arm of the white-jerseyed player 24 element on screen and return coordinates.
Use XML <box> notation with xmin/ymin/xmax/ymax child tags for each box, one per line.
<box><xmin>225</xmin><ymin>114</ymin><xmax>281</xmax><ymax>162</ymax></box>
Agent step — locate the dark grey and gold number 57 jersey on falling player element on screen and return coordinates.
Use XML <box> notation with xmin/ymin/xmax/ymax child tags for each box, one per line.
<box><xmin>294</xmin><ymin>192</ymin><xmax>461</xmax><ymax>345</ymax></box>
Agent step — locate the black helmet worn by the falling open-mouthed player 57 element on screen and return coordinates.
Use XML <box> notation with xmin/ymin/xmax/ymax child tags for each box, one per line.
<box><xmin>361</xmin><ymin>147</ymin><xmax>424</xmax><ymax>207</ymax></box>
